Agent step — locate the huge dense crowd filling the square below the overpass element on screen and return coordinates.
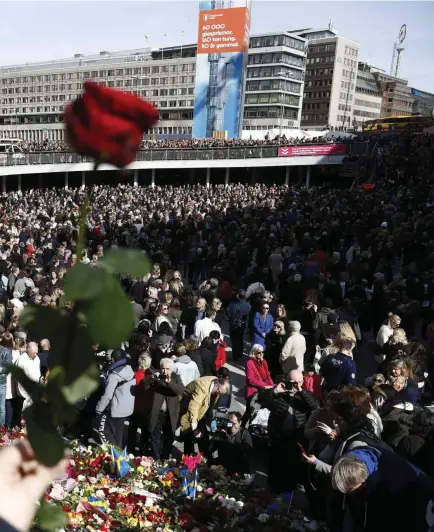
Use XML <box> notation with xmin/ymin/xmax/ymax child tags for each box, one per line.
<box><xmin>0</xmin><ymin>131</ymin><xmax>434</xmax><ymax>532</ymax></box>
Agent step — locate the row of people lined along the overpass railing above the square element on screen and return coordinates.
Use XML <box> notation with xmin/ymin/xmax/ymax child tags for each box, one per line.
<box><xmin>14</xmin><ymin>135</ymin><xmax>348</xmax><ymax>153</ymax></box>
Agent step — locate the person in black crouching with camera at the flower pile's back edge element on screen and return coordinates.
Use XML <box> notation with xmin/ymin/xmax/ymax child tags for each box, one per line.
<box><xmin>211</xmin><ymin>412</ymin><xmax>253</xmax><ymax>475</ymax></box>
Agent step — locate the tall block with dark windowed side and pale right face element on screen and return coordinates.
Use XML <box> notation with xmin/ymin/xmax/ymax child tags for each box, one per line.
<box><xmin>290</xmin><ymin>24</ymin><xmax>359</xmax><ymax>129</ymax></box>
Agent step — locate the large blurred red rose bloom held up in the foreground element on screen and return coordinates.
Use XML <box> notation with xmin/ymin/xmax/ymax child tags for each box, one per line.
<box><xmin>65</xmin><ymin>81</ymin><xmax>158</xmax><ymax>168</ymax></box>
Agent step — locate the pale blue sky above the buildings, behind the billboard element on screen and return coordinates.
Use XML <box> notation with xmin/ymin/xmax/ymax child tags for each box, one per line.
<box><xmin>0</xmin><ymin>0</ymin><xmax>434</xmax><ymax>93</ymax></box>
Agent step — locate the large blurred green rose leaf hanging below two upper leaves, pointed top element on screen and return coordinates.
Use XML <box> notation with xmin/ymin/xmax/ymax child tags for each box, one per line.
<box><xmin>87</xmin><ymin>277</ymin><xmax>134</xmax><ymax>348</ymax></box>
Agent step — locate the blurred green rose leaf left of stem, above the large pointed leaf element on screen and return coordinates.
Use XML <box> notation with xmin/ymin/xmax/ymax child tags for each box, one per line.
<box><xmin>64</xmin><ymin>262</ymin><xmax>107</xmax><ymax>301</ymax></box>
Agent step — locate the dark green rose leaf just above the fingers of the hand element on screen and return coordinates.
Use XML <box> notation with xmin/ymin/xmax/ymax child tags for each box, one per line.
<box><xmin>24</xmin><ymin>403</ymin><xmax>64</xmax><ymax>467</ymax></box>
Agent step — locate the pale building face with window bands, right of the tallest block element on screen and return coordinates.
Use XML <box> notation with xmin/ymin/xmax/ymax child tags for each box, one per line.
<box><xmin>352</xmin><ymin>62</ymin><xmax>383</xmax><ymax>129</ymax></box>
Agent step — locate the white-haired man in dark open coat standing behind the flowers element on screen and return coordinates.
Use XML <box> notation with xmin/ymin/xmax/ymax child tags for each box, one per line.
<box><xmin>143</xmin><ymin>358</ymin><xmax>184</xmax><ymax>460</ymax></box>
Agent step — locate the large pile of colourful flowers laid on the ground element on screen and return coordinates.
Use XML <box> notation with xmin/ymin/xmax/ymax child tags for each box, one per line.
<box><xmin>0</xmin><ymin>429</ymin><xmax>310</xmax><ymax>532</ymax></box>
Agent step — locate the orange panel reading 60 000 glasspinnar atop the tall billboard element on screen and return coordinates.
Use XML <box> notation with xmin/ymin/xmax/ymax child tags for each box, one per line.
<box><xmin>197</xmin><ymin>7</ymin><xmax>250</xmax><ymax>54</ymax></box>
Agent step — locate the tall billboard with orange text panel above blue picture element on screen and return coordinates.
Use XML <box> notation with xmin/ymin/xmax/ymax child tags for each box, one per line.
<box><xmin>193</xmin><ymin>0</ymin><xmax>251</xmax><ymax>138</ymax></box>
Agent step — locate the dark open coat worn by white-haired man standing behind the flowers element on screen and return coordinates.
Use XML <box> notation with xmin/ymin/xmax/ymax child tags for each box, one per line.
<box><xmin>142</xmin><ymin>373</ymin><xmax>184</xmax><ymax>432</ymax></box>
